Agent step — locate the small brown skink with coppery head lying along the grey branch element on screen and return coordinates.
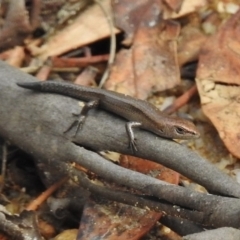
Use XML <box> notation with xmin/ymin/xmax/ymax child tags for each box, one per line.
<box><xmin>17</xmin><ymin>81</ymin><xmax>200</xmax><ymax>151</ymax></box>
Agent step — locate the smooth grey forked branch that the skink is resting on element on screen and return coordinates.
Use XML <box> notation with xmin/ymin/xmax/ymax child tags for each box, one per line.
<box><xmin>0</xmin><ymin>62</ymin><xmax>240</xmax><ymax>227</ymax></box>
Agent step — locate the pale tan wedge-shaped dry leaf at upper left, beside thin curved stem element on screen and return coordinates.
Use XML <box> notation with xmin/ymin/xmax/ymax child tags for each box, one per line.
<box><xmin>31</xmin><ymin>0</ymin><xmax>119</xmax><ymax>59</ymax></box>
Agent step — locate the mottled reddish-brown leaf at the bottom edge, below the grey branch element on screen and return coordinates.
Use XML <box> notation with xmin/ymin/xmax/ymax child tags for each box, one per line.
<box><xmin>79</xmin><ymin>201</ymin><xmax>159</xmax><ymax>240</ymax></box>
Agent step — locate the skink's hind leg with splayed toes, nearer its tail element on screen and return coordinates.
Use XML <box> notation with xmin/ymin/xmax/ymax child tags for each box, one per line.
<box><xmin>64</xmin><ymin>100</ymin><xmax>99</xmax><ymax>137</ymax></box>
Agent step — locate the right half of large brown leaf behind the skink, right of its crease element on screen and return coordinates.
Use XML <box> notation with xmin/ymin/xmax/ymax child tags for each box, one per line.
<box><xmin>133</xmin><ymin>17</ymin><xmax>180</xmax><ymax>99</ymax></box>
